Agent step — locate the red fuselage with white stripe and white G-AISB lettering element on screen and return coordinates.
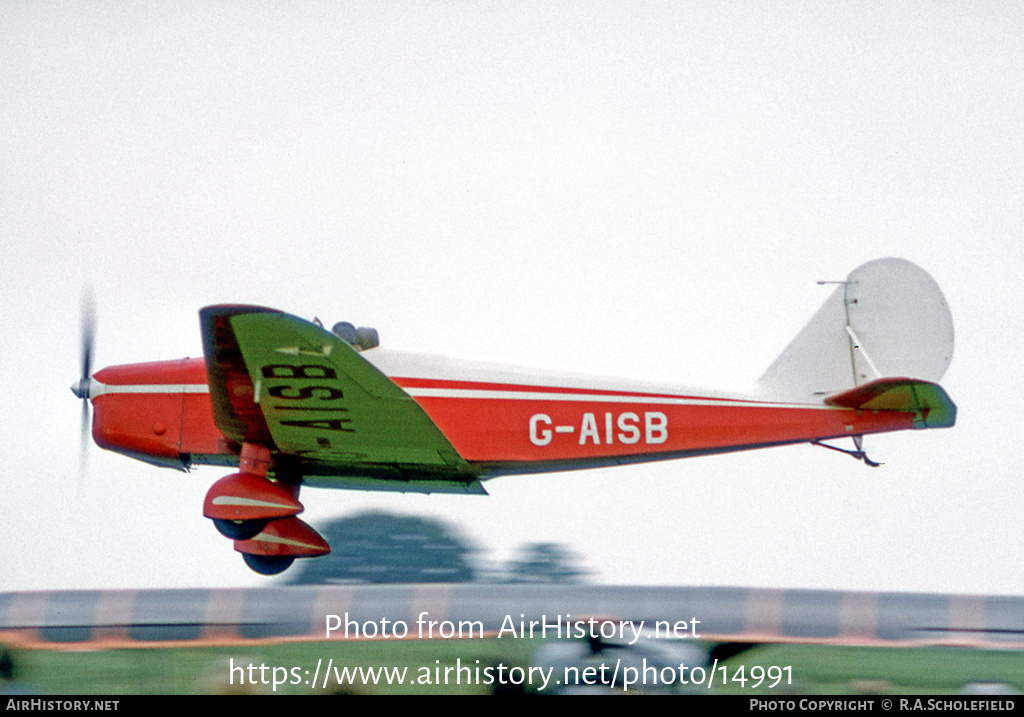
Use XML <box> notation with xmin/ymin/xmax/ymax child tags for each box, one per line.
<box><xmin>91</xmin><ymin>349</ymin><xmax>913</xmax><ymax>477</ymax></box>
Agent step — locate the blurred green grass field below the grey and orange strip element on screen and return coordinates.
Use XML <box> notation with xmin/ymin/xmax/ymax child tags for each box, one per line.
<box><xmin>4</xmin><ymin>639</ymin><xmax>1024</xmax><ymax>694</ymax></box>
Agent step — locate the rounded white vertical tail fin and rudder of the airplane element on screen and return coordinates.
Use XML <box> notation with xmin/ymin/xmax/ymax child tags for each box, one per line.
<box><xmin>760</xmin><ymin>258</ymin><xmax>955</xmax><ymax>405</ymax></box>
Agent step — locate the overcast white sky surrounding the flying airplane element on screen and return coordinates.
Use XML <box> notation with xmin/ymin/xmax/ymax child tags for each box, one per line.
<box><xmin>0</xmin><ymin>0</ymin><xmax>1024</xmax><ymax>594</ymax></box>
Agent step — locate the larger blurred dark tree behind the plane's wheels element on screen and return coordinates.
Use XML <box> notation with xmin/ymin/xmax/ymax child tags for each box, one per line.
<box><xmin>289</xmin><ymin>512</ymin><xmax>475</xmax><ymax>585</ymax></box>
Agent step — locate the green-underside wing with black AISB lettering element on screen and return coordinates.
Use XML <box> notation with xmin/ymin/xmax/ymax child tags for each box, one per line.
<box><xmin>200</xmin><ymin>305</ymin><xmax>465</xmax><ymax>474</ymax></box>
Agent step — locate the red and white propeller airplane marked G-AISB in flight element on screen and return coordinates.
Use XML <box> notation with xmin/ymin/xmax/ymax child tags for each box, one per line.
<box><xmin>72</xmin><ymin>258</ymin><xmax>956</xmax><ymax>575</ymax></box>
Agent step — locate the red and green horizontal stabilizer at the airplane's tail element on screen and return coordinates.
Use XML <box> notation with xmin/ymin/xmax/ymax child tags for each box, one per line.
<box><xmin>825</xmin><ymin>378</ymin><xmax>956</xmax><ymax>428</ymax></box>
